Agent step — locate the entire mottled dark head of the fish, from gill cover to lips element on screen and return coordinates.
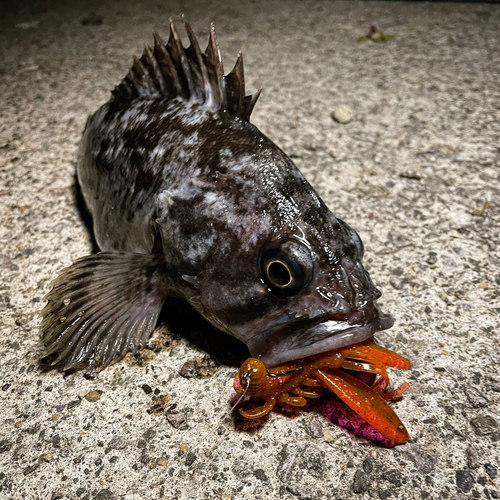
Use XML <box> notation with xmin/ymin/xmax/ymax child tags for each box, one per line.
<box><xmin>158</xmin><ymin>122</ymin><xmax>393</xmax><ymax>366</ymax></box>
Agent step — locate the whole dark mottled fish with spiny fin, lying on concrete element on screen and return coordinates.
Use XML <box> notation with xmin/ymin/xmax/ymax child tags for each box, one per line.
<box><xmin>40</xmin><ymin>20</ymin><xmax>394</xmax><ymax>370</ymax></box>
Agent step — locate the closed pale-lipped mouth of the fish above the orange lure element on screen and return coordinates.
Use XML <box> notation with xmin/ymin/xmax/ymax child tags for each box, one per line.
<box><xmin>248</xmin><ymin>307</ymin><xmax>394</xmax><ymax>367</ymax></box>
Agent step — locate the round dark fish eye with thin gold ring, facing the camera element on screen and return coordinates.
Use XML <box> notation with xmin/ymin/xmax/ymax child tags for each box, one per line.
<box><xmin>261</xmin><ymin>240</ymin><xmax>314</xmax><ymax>295</ymax></box>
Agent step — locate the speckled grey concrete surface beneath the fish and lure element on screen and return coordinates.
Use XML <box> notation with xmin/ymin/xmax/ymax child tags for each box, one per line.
<box><xmin>0</xmin><ymin>0</ymin><xmax>500</xmax><ymax>500</ymax></box>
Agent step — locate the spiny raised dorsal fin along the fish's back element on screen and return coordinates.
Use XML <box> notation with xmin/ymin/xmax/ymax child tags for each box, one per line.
<box><xmin>112</xmin><ymin>20</ymin><xmax>262</xmax><ymax>121</ymax></box>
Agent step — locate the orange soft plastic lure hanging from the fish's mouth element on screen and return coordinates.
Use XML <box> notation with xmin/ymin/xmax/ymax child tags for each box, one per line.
<box><xmin>234</xmin><ymin>341</ymin><xmax>410</xmax><ymax>444</ymax></box>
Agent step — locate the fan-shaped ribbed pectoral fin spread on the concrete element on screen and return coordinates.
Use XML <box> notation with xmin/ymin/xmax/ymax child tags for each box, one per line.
<box><xmin>40</xmin><ymin>252</ymin><xmax>168</xmax><ymax>370</ymax></box>
